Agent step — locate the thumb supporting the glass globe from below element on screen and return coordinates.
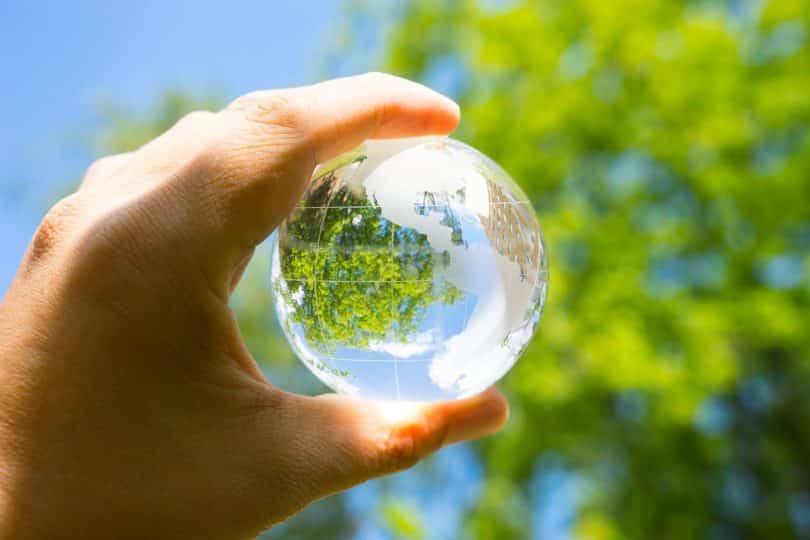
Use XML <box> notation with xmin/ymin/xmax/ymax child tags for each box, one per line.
<box><xmin>274</xmin><ymin>389</ymin><xmax>509</xmax><ymax>502</ymax></box>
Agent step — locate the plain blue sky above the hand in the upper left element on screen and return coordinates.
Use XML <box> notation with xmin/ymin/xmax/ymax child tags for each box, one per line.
<box><xmin>0</xmin><ymin>0</ymin><xmax>340</xmax><ymax>294</ymax></box>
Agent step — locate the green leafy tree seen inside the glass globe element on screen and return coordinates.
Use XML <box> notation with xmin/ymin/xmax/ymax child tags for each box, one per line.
<box><xmin>274</xmin><ymin>155</ymin><xmax>462</xmax><ymax>352</ymax></box>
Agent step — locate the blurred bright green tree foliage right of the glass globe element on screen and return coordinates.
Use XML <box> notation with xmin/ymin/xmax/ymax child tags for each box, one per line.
<box><xmin>372</xmin><ymin>0</ymin><xmax>810</xmax><ymax>538</ymax></box>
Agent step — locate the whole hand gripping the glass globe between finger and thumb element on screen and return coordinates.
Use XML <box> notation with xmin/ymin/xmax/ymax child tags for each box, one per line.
<box><xmin>0</xmin><ymin>74</ymin><xmax>508</xmax><ymax>539</ymax></box>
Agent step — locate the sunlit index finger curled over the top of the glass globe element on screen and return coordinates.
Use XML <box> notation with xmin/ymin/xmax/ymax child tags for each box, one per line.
<box><xmin>185</xmin><ymin>73</ymin><xmax>459</xmax><ymax>282</ymax></box>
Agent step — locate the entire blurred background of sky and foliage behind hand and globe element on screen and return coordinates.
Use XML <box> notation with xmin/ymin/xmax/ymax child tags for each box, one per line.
<box><xmin>0</xmin><ymin>0</ymin><xmax>810</xmax><ymax>540</ymax></box>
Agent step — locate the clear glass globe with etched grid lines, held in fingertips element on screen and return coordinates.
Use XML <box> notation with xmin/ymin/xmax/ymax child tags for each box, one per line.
<box><xmin>271</xmin><ymin>137</ymin><xmax>548</xmax><ymax>401</ymax></box>
